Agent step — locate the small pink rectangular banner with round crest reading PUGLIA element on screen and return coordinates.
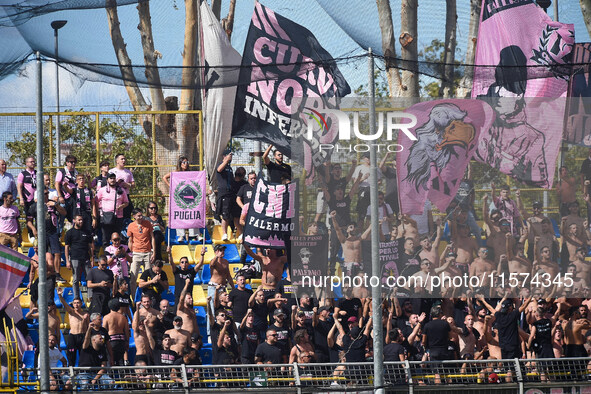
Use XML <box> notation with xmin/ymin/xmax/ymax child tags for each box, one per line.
<box><xmin>168</xmin><ymin>171</ymin><xmax>206</xmax><ymax>229</ymax></box>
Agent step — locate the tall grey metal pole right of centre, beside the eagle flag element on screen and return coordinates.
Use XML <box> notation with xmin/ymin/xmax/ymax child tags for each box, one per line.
<box><xmin>368</xmin><ymin>48</ymin><xmax>384</xmax><ymax>394</ymax></box>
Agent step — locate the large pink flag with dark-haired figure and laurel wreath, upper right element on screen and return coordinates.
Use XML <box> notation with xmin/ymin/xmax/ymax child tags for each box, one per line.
<box><xmin>472</xmin><ymin>0</ymin><xmax>574</xmax><ymax>188</ymax></box>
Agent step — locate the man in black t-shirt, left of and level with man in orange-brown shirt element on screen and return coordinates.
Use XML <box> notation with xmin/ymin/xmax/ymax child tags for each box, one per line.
<box><xmin>65</xmin><ymin>215</ymin><xmax>94</xmax><ymax>296</ymax></box>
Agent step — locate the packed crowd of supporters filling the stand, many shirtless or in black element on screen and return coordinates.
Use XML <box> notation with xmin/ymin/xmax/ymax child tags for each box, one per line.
<box><xmin>0</xmin><ymin>147</ymin><xmax>591</xmax><ymax>381</ymax></box>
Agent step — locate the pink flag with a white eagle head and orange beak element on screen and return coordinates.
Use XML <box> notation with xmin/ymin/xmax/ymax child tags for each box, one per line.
<box><xmin>396</xmin><ymin>99</ymin><xmax>493</xmax><ymax>214</ymax></box>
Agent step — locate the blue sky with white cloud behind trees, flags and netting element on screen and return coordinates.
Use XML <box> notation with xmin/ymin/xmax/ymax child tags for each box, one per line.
<box><xmin>0</xmin><ymin>0</ymin><xmax>589</xmax><ymax>112</ymax></box>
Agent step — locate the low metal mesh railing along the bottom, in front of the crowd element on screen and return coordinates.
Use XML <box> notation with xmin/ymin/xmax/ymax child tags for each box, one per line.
<box><xmin>13</xmin><ymin>358</ymin><xmax>591</xmax><ymax>392</ymax></box>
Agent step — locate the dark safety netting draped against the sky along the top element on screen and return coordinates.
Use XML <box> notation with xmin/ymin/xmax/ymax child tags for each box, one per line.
<box><xmin>0</xmin><ymin>0</ymin><xmax>589</xmax><ymax>94</ymax></box>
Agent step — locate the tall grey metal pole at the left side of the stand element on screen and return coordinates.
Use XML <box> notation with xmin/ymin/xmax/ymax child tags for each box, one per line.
<box><xmin>35</xmin><ymin>52</ymin><xmax>49</xmax><ymax>393</ymax></box>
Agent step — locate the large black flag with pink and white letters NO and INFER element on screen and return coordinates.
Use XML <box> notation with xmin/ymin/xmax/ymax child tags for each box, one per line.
<box><xmin>232</xmin><ymin>2</ymin><xmax>351</xmax><ymax>162</ymax></box>
